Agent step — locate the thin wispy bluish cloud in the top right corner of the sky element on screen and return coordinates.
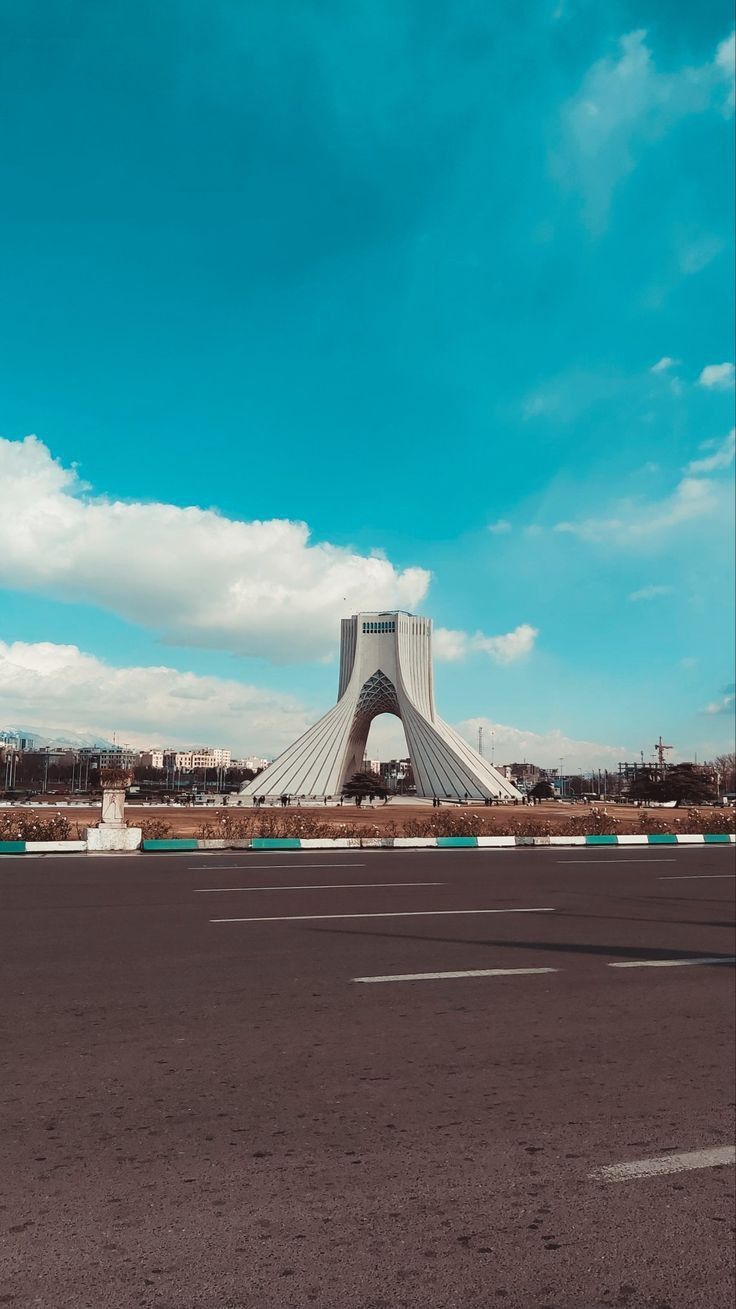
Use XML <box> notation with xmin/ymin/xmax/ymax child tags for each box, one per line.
<box><xmin>553</xmin><ymin>29</ymin><xmax>733</xmax><ymax>229</ymax></box>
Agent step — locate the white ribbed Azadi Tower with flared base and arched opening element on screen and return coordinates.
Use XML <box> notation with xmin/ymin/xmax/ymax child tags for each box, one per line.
<box><xmin>241</xmin><ymin>611</ymin><xmax>520</xmax><ymax>800</ymax></box>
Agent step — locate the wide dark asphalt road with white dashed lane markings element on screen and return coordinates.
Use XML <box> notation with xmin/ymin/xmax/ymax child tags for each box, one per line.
<box><xmin>0</xmin><ymin>847</ymin><xmax>736</xmax><ymax>1309</ymax></box>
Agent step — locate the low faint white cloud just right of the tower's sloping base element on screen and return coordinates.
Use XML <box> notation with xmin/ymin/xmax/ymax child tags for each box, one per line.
<box><xmin>457</xmin><ymin>719</ymin><xmax>630</xmax><ymax>772</ymax></box>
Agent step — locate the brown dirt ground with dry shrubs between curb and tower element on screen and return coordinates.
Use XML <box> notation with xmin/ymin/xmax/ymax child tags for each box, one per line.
<box><xmin>0</xmin><ymin>801</ymin><xmax>733</xmax><ymax>836</ymax></box>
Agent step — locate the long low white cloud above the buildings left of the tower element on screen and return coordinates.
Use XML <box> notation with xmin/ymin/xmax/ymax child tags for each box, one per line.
<box><xmin>0</xmin><ymin>641</ymin><xmax>311</xmax><ymax>754</ymax></box>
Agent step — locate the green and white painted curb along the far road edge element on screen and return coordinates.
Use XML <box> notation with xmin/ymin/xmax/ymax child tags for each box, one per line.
<box><xmin>0</xmin><ymin>831</ymin><xmax>736</xmax><ymax>855</ymax></box>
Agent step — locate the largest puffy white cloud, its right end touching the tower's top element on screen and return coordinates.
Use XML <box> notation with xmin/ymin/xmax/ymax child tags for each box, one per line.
<box><xmin>0</xmin><ymin>436</ymin><xmax>430</xmax><ymax>661</ymax></box>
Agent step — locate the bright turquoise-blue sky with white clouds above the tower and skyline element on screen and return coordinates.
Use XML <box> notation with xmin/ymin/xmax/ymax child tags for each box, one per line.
<box><xmin>0</xmin><ymin>0</ymin><xmax>733</xmax><ymax>766</ymax></box>
